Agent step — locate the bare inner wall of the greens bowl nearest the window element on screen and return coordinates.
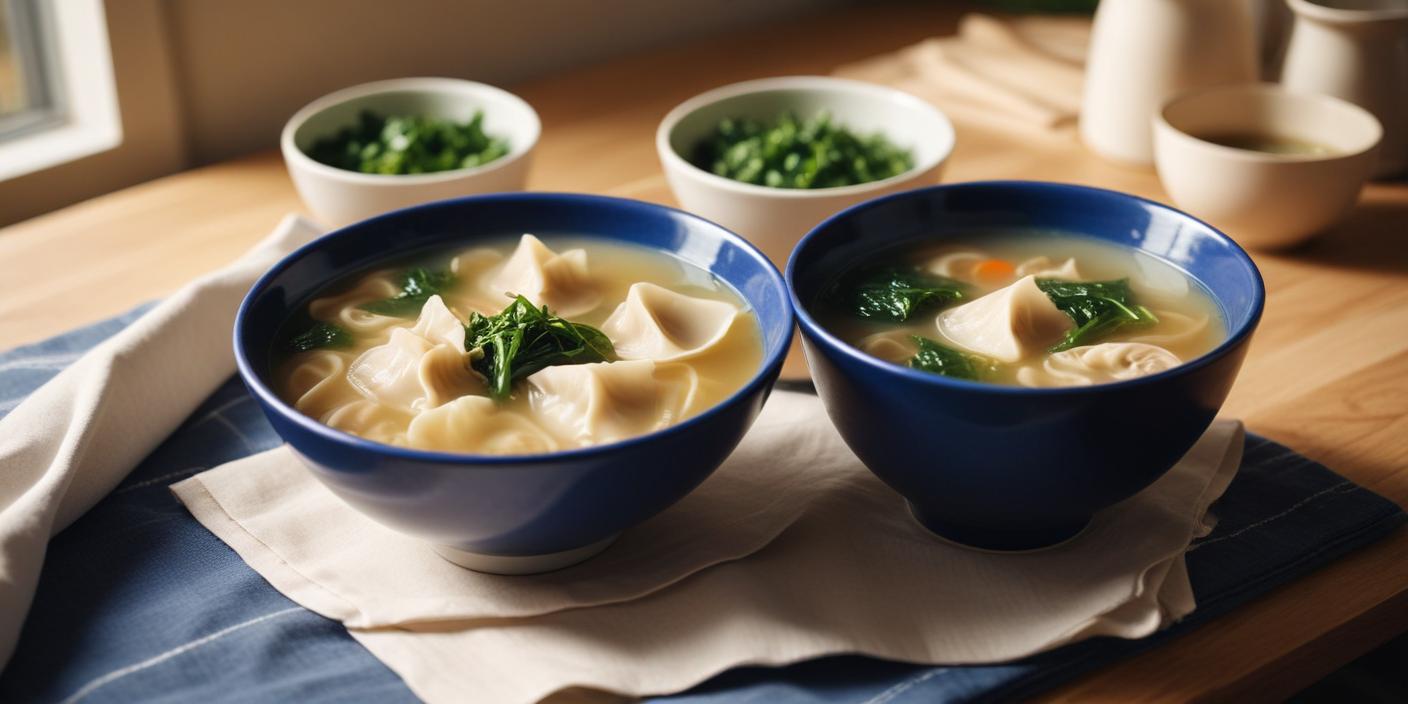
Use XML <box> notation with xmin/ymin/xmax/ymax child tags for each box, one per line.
<box><xmin>293</xmin><ymin>80</ymin><xmax>539</xmax><ymax>159</ymax></box>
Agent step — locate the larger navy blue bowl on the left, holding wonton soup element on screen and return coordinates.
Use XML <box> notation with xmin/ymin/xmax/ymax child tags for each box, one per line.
<box><xmin>235</xmin><ymin>193</ymin><xmax>793</xmax><ymax>572</ymax></box>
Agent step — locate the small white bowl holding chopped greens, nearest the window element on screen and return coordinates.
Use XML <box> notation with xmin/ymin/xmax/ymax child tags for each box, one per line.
<box><xmin>279</xmin><ymin>77</ymin><xmax>542</xmax><ymax>227</ymax></box>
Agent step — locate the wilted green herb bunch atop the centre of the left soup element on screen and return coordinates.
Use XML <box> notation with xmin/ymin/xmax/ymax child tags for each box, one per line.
<box><xmin>465</xmin><ymin>296</ymin><xmax>615</xmax><ymax>401</ymax></box>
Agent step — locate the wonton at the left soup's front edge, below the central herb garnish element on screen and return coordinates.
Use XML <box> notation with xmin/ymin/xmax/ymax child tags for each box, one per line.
<box><xmin>406</xmin><ymin>396</ymin><xmax>559</xmax><ymax>455</ymax></box>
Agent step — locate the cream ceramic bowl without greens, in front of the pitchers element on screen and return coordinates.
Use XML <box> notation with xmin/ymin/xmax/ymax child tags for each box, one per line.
<box><xmin>1153</xmin><ymin>83</ymin><xmax>1383</xmax><ymax>249</ymax></box>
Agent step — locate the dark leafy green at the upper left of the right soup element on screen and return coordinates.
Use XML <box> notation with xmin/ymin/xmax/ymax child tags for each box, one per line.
<box><xmin>834</xmin><ymin>268</ymin><xmax>963</xmax><ymax>322</ymax></box>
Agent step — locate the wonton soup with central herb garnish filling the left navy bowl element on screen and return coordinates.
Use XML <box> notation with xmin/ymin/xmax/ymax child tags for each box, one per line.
<box><xmin>275</xmin><ymin>235</ymin><xmax>763</xmax><ymax>455</ymax></box>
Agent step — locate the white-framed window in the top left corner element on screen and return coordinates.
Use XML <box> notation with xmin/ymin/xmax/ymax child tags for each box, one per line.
<box><xmin>0</xmin><ymin>0</ymin><xmax>122</xmax><ymax>180</ymax></box>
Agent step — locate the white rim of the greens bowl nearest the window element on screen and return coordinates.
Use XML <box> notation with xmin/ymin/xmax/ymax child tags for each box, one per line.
<box><xmin>279</xmin><ymin>76</ymin><xmax>542</xmax><ymax>186</ymax></box>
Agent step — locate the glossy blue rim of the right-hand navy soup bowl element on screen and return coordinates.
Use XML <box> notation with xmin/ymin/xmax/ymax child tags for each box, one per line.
<box><xmin>784</xmin><ymin>180</ymin><xmax>1266</xmax><ymax>397</ymax></box>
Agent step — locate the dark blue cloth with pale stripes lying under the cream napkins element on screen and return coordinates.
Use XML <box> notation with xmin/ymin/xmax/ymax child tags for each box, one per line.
<box><xmin>0</xmin><ymin>308</ymin><xmax>1404</xmax><ymax>704</ymax></box>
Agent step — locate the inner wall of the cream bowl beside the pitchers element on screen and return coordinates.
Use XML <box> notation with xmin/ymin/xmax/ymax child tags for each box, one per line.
<box><xmin>1163</xmin><ymin>84</ymin><xmax>1381</xmax><ymax>161</ymax></box>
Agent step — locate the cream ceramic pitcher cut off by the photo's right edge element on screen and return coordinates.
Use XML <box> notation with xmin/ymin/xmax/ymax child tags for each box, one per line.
<box><xmin>1281</xmin><ymin>0</ymin><xmax>1408</xmax><ymax>176</ymax></box>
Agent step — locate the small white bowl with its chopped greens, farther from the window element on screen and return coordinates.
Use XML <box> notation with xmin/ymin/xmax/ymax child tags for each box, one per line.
<box><xmin>656</xmin><ymin>76</ymin><xmax>955</xmax><ymax>266</ymax></box>
